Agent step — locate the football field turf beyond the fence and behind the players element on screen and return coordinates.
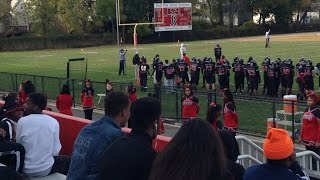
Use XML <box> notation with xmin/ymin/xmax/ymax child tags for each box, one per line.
<box><xmin>0</xmin><ymin>32</ymin><xmax>320</xmax><ymax>82</ymax></box>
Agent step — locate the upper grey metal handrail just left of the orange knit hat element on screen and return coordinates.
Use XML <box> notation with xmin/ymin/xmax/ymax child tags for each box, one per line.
<box><xmin>236</xmin><ymin>136</ymin><xmax>266</xmax><ymax>162</ymax></box>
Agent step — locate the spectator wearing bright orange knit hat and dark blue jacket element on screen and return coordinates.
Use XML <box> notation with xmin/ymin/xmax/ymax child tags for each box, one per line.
<box><xmin>243</xmin><ymin>128</ymin><xmax>309</xmax><ymax>180</ymax></box>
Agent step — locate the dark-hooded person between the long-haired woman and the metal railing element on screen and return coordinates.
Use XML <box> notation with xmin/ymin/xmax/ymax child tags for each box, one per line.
<box><xmin>219</xmin><ymin>129</ymin><xmax>245</xmax><ymax>180</ymax></box>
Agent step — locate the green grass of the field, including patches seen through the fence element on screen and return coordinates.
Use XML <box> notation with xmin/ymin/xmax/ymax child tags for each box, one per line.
<box><xmin>0</xmin><ymin>33</ymin><xmax>320</xmax><ymax>136</ymax></box>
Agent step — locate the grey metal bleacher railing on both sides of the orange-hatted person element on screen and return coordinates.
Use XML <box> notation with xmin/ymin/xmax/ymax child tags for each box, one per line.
<box><xmin>236</xmin><ymin>136</ymin><xmax>320</xmax><ymax>179</ymax></box>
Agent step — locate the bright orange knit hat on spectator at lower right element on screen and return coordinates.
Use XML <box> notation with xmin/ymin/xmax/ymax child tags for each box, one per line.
<box><xmin>263</xmin><ymin>128</ymin><xmax>294</xmax><ymax>160</ymax></box>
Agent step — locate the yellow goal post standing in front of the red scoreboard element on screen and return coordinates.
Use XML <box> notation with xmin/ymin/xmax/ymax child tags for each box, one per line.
<box><xmin>116</xmin><ymin>0</ymin><xmax>164</xmax><ymax>49</ymax></box>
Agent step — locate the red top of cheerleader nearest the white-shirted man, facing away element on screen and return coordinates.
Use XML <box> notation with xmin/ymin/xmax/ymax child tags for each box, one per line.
<box><xmin>56</xmin><ymin>94</ymin><xmax>73</xmax><ymax>116</ymax></box>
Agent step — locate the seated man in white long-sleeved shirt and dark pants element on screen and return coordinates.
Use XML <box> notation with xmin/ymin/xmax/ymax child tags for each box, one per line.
<box><xmin>17</xmin><ymin>93</ymin><xmax>70</xmax><ymax>177</ymax></box>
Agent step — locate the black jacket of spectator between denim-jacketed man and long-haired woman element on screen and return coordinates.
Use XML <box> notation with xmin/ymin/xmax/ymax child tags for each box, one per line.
<box><xmin>99</xmin><ymin>130</ymin><xmax>156</xmax><ymax>180</ymax></box>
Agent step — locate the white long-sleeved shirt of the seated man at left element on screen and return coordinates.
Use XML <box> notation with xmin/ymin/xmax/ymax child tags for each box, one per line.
<box><xmin>17</xmin><ymin>114</ymin><xmax>61</xmax><ymax>174</ymax></box>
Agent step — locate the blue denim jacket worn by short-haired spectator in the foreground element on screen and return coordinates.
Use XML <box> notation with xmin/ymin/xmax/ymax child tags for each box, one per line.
<box><xmin>67</xmin><ymin>116</ymin><xmax>123</xmax><ymax>180</ymax></box>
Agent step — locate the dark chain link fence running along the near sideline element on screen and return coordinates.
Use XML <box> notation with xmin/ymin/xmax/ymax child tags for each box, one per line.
<box><xmin>0</xmin><ymin>72</ymin><xmax>307</xmax><ymax>138</ymax></box>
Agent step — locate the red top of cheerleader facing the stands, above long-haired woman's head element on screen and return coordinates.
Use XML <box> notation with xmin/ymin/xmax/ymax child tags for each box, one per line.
<box><xmin>182</xmin><ymin>95</ymin><xmax>200</xmax><ymax>120</ymax></box>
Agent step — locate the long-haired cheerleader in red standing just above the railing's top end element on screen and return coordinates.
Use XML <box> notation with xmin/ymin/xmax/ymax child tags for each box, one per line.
<box><xmin>223</xmin><ymin>89</ymin><xmax>239</xmax><ymax>135</ymax></box>
